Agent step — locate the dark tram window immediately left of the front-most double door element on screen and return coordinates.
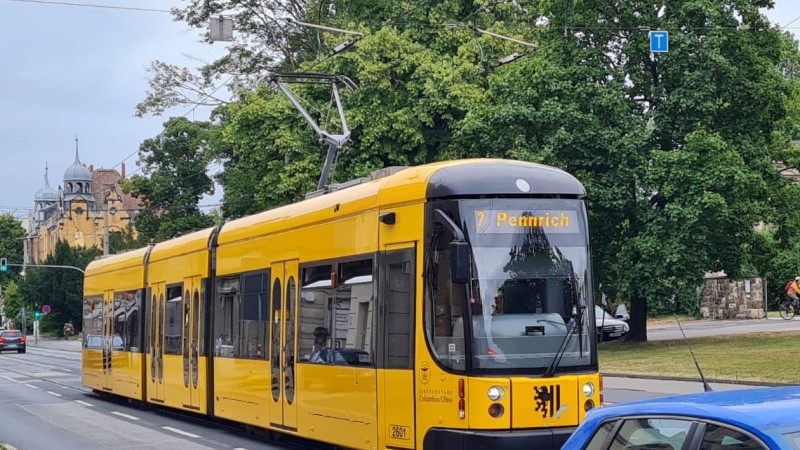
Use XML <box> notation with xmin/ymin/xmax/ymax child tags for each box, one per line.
<box><xmin>238</xmin><ymin>272</ymin><xmax>269</xmax><ymax>359</ymax></box>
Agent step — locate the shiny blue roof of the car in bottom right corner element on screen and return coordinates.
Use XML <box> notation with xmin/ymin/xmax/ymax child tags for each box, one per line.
<box><xmin>586</xmin><ymin>386</ymin><xmax>800</xmax><ymax>431</ymax></box>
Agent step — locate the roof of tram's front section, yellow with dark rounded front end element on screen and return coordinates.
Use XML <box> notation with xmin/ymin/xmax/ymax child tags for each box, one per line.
<box><xmin>218</xmin><ymin>159</ymin><xmax>586</xmax><ymax>245</ymax></box>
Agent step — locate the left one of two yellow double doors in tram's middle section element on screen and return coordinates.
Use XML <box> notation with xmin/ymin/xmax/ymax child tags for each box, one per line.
<box><xmin>147</xmin><ymin>283</ymin><xmax>166</xmax><ymax>403</ymax></box>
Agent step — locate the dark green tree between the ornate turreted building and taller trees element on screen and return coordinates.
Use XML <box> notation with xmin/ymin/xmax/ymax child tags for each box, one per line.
<box><xmin>121</xmin><ymin>117</ymin><xmax>214</xmax><ymax>241</ymax></box>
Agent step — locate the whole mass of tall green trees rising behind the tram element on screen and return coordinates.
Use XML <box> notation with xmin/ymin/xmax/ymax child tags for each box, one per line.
<box><xmin>139</xmin><ymin>0</ymin><xmax>800</xmax><ymax>340</ymax></box>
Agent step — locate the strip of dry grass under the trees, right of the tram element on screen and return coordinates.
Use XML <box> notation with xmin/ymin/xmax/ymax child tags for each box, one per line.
<box><xmin>598</xmin><ymin>330</ymin><xmax>800</xmax><ymax>384</ymax></box>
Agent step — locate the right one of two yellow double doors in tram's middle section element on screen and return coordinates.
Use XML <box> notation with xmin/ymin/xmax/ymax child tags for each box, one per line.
<box><xmin>181</xmin><ymin>275</ymin><xmax>200</xmax><ymax>409</ymax></box>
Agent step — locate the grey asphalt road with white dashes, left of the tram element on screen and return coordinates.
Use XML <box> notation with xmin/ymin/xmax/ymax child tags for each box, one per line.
<box><xmin>0</xmin><ymin>338</ymin><xmax>287</xmax><ymax>450</ymax></box>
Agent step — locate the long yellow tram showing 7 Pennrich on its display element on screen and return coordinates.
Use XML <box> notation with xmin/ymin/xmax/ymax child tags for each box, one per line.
<box><xmin>83</xmin><ymin>159</ymin><xmax>601</xmax><ymax>449</ymax></box>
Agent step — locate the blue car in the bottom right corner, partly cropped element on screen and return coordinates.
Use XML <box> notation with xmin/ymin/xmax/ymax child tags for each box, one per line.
<box><xmin>562</xmin><ymin>386</ymin><xmax>800</xmax><ymax>450</ymax></box>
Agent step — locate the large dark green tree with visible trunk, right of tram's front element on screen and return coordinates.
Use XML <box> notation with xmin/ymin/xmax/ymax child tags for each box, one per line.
<box><xmin>528</xmin><ymin>0</ymin><xmax>796</xmax><ymax>340</ymax></box>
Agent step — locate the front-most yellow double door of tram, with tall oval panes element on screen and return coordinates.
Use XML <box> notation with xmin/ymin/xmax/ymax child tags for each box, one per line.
<box><xmin>269</xmin><ymin>259</ymin><xmax>298</xmax><ymax>430</ymax></box>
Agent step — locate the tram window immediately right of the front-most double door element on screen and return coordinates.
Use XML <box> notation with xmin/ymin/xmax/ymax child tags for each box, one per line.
<box><xmin>297</xmin><ymin>264</ymin><xmax>333</xmax><ymax>364</ymax></box>
